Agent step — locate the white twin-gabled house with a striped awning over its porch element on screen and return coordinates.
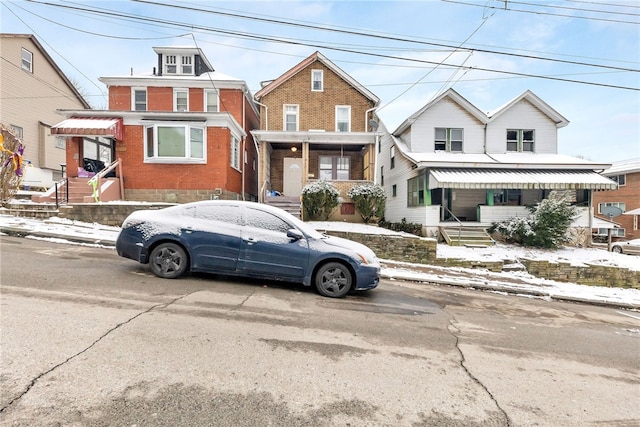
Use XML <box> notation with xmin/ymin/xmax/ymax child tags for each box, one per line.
<box><xmin>377</xmin><ymin>89</ymin><xmax>617</xmax><ymax>242</ymax></box>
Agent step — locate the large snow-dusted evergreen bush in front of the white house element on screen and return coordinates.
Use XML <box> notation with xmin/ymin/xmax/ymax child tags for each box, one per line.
<box><xmin>489</xmin><ymin>197</ymin><xmax>578</xmax><ymax>248</ymax></box>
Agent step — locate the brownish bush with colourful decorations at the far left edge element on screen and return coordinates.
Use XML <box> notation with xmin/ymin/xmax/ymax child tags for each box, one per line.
<box><xmin>0</xmin><ymin>125</ymin><xmax>24</xmax><ymax>203</ymax></box>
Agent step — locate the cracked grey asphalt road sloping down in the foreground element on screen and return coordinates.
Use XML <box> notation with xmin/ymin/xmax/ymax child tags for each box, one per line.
<box><xmin>0</xmin><ymin>236</ymin><xmax>640</xmax><ymax>426</ymax></box>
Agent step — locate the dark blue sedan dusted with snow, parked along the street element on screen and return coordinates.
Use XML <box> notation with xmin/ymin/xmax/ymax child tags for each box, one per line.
<box><xmin>116</xmin><ymin>200</ymin><xmax>380</xmax><ymax>298</ymax></box>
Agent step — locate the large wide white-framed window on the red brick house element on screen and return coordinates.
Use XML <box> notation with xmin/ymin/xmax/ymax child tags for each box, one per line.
<box><xmin>145</xmin><ymin>124</ymin><xmax>206</xmax><ymax>163</ymax></box>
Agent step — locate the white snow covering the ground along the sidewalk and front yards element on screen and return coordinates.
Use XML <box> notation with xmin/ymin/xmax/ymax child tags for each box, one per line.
<box><xmin>0</xmin><ymin>216</ymin><xmax>640</xmax><ymax>308</ymax></box>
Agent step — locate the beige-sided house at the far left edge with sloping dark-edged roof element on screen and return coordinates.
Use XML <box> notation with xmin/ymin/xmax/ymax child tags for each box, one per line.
<box><xmin>0</xmin><ymin>34</ymin><xmax>91</xmax><ymax>188</ymax></box>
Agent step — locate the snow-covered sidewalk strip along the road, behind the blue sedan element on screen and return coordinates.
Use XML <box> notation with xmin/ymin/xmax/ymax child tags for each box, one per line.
<box><xmin>0</xmin><ymin>213</ymin><xmax>640</xmax><ymax>310</ymax></box>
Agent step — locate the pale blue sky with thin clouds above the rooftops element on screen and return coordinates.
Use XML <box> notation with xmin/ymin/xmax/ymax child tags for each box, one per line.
<box><xmin>0</xmin><ymin>0</ymin><xmax>640</xmax><ymax>162</ymax></box>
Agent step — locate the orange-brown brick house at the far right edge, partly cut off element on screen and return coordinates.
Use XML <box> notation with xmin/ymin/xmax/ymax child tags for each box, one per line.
<box><xmin>593</xmin><ymin>159</ymin><xmax>640</xmax><ymax>240</ymax></box>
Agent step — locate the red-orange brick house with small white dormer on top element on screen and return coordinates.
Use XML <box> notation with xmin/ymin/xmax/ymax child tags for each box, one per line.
<box><xmin>48</xmin><ymin>46</ymin><xmax>258</xmax><ymax>203</ymax></box>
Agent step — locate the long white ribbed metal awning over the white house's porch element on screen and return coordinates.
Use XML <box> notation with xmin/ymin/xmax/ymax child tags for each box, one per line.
<box><xmin>429</xmin><ymin>168</ymin><xmax>618</xmax><ymax>190</ymax></box>
